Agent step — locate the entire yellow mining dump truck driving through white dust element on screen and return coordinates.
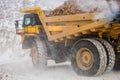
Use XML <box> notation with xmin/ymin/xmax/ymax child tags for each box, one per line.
<box><xmin>15</xmin><ymin>8</ymin><xmax>120</xmax><ymax>76</ymax></box>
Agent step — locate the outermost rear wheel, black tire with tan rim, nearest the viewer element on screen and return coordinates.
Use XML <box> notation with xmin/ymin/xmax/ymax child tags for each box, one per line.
<box><xmin>71</xmin><ymin>39</ymin><xmax>107</xmax><ymax>76</ymax></box>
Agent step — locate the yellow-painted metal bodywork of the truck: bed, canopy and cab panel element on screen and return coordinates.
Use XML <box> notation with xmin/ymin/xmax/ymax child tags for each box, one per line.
<box><xmin>20</xmin><ymin>7</ymin><xmax>120</xmax><ymax>42</ymax></box>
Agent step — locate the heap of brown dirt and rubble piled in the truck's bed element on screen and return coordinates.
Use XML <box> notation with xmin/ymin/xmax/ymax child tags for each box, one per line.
<box><xmin>49</xmin><ymin>0</ymin><xmax>82</xmax><ymax>16</ymax></box>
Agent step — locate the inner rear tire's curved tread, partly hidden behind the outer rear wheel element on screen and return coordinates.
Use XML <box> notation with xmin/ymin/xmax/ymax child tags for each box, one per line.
<box><xmin>97</xmin><ymin>39</ymin><xmax>115</xmax><ymax>72</ymax></box>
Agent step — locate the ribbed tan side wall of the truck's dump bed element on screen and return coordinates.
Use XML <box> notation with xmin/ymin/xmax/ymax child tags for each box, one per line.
<box><xmin>44</xmin><ymin>13</ymin><xmax>108</xmax><ymax>41</ymax></box>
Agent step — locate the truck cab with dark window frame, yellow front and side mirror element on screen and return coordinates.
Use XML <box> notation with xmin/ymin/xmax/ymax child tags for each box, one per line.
<box><xmin>15</xmin><ymin>13</ymin><xmax>42</xmax><ymax>35</ymax></box>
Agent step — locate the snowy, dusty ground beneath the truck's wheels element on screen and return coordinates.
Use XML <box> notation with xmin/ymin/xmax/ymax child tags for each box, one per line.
<box><xmin>0</xmin><ymin>58</ymin><xmax>120</xmax><ymax>80</ymax></box>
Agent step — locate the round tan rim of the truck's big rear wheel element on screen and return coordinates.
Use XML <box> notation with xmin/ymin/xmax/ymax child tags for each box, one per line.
<box><xmin>76</xmin><ymin>48</ymin><xmax>94</xmax><ymax>70</ymax></box>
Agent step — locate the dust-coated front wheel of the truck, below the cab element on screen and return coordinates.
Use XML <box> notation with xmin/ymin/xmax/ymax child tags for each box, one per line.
<box><xmin>31</xmin><ymin>39</ymin><xmax>47</xmax><ymax>69</ymax></box>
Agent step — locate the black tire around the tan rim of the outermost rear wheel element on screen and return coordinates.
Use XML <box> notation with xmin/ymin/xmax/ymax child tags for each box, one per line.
<box><xmin>71</xmin><ymin>39</ymin><xmax>107</xmax><ymax>76</ymax></box>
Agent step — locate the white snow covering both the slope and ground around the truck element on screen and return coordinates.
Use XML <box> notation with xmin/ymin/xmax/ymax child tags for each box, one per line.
<box><xmin>0</xmin><ymin>0</ymin><xmax>120</xmax><ymax>80</ymax></box>
